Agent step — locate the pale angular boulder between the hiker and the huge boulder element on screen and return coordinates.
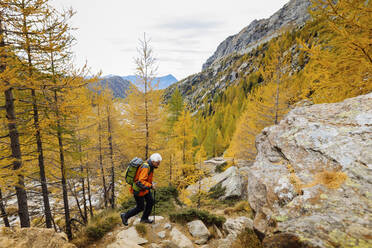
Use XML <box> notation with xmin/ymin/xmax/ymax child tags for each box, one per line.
<box><xmin>186</xmin><ymin>166</ymin><xmax>244</xmax><ymax>200</ymax></box>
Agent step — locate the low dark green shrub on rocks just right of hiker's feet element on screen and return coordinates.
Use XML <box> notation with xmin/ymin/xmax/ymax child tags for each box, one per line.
<box><xmin>169</xmin><ymin>208</ymin><xmax>226</xmax><ymax>227</ymax></box>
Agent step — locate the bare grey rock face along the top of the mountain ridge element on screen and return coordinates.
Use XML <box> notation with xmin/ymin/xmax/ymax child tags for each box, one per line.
<box><xmin>202</xmin><ymin>0</ymin><xmax>310</xmax><ymax>70</ymax></box>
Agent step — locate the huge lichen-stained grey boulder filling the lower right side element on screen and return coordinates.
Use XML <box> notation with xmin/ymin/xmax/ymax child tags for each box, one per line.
<box><xmin>247</xmin><ymin>93</ymin><xmax>372</xmax><ymax>247</ymax></box>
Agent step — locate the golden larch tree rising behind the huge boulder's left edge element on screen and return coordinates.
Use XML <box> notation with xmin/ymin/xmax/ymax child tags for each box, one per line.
<box><xmin>227</xmin><ymin>38</ymin><xmax>301</xmax><ymax>161</ymax></box>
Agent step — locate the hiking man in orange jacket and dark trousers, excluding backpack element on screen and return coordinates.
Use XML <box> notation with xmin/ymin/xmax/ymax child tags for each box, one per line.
<box><xmin>120</xmin><ymin>153</ymin><xmax>162</xmax><ymax>226</ymax></box>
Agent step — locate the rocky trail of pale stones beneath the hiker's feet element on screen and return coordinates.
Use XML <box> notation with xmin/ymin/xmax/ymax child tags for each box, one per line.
<box><xmin>85</xmin><ymin>213</ymin><xmax>253</xmax><ymax>248</ymax></box>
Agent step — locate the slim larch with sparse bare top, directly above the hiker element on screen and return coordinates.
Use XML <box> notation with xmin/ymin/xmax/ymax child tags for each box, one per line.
<box><xmin>123</xmin><ymin>36</ymin><xmax>165</xmax><ymax>160</ymax></box>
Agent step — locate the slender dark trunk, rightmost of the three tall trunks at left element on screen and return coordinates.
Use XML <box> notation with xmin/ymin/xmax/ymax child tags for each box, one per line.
<box><xmin>54</xmin><ymin>91</ymin><xmax>72</xmax><ymax>240</ymax></box>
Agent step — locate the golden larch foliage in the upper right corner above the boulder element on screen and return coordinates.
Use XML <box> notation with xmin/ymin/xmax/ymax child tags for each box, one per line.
<box><xmin>300</xmin><ymin>0</ymin><xmax>372</xmax><ymax>103</ymax></box>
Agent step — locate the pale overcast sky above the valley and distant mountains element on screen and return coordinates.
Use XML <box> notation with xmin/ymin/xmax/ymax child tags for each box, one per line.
<box><xmin>51</xmin><ymin>0</ymin><xmax>288</xmax><ymax>80</ymax></box>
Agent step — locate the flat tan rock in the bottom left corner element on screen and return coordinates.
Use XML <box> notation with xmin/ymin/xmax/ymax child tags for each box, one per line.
<box><xmin>0</xmin><ymin>227</ymin><xmax>76</xmax><ymax>248</ymax></box>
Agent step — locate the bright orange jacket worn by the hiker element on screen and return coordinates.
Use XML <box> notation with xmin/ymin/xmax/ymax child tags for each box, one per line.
<box><xmin>130</xmin><ymin>162</ymin><xmax>154</xmax><ymax>196</ymax></box>
